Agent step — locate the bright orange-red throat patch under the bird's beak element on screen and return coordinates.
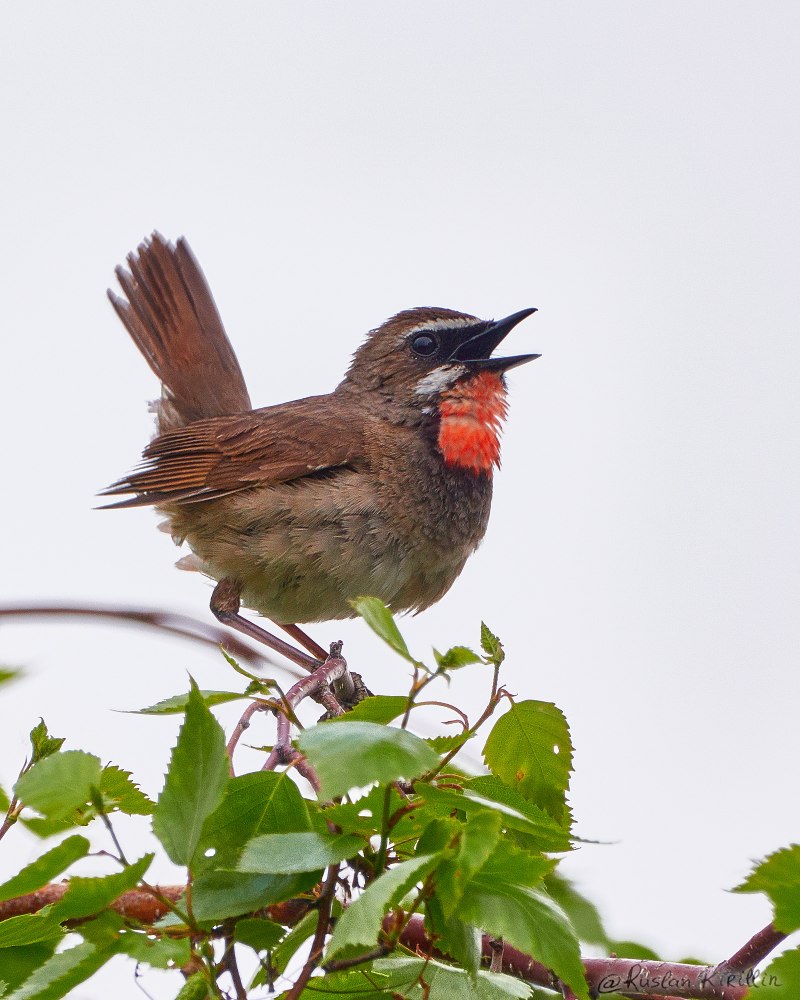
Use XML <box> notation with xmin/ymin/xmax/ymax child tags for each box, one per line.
<box><xmin>438</xmin><ymin>372</ymin><xmax>508</xmax><ymax>475</ymax></box>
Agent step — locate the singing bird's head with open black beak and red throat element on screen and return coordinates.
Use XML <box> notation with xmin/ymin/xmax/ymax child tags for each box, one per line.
<box><xmin>340</xmin><ymin>307</ymin><xmax>539</xmax><ymax>473</ymax></box>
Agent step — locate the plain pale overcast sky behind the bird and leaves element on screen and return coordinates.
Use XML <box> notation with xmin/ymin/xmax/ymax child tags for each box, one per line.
<box><xmin>0</xmin><ymin>0</ymin><xmax>800</xmax><ymax>998</ymax></box>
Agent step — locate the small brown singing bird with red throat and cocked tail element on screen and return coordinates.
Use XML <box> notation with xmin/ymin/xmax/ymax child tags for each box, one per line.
<box><xmin>104</xmin><ymin>233</ymin><xmax>539</xmax><ymax>656</ymax></box>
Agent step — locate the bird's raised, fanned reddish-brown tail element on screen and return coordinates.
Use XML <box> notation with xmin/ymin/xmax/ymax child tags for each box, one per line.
<box><xmin>108</xmin><ymin>233</ymin><xmax>252</xmax><ymax>434</ymax></box>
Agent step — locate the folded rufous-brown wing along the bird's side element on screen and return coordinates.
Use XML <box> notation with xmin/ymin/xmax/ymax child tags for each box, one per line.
<box><xmin>103</xmin><ymin>396</ymin><xmax>364</xmax><ymax>507</ymax></box>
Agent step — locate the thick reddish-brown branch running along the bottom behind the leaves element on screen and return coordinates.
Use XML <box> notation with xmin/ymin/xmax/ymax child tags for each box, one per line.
<box><xmin>0</xmin><ymin>888</ymin><xmax>786</xmax><ymax>1000</ymax></box>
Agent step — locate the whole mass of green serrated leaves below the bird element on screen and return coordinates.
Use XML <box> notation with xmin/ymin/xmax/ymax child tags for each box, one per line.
<box><xmin>0</xmin><ymin>599</ymin><xmax>800</xmax><ymax>1000</ymax></box>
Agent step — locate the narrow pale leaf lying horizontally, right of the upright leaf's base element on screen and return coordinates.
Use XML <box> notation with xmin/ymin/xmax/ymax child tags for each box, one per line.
<box><xmin>237</xmin><ymin>831</ymin><xmax>364</xmax><ymax>875</ymax></box>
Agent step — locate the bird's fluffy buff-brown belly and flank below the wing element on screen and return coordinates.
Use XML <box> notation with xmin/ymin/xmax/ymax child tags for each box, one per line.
<box><xmin>164</xmin><ymin>471</ymin><xmax>488</xmax><ymax>623</ymax></box>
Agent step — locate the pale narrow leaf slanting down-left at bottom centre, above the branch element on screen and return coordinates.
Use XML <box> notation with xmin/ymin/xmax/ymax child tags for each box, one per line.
<box><xmin>328</xmin><ymin>854</ymin><xmax>439</xmax><ymax>958</ymax></box>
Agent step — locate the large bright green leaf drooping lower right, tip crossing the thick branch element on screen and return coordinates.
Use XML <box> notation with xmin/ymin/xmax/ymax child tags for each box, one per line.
<box><xmin>458</xmin><ymin>841</ymin><xmax>588</xmax><ymax>1000</ymax></box>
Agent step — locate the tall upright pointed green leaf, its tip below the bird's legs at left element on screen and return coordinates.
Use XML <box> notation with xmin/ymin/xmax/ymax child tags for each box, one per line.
<box><xmin>153</xmin><ymin>681</ymin><xmax>229</xmax><ymax>865</ymax></box>
